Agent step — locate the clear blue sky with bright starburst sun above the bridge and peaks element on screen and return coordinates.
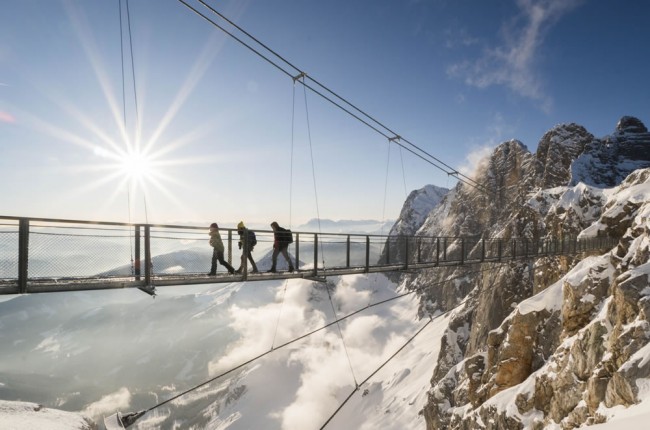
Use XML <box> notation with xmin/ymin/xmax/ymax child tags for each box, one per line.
<box><xmin>0</xmin><ymin>0</ymin><xmax>650</xmax><ymax>227</ymax></box>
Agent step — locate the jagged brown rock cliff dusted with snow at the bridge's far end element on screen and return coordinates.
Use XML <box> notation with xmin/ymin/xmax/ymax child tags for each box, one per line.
<box><xmin>400</xmin><ymin>117</ymin><xmax>650</xmax><ymax>429</ymax></box>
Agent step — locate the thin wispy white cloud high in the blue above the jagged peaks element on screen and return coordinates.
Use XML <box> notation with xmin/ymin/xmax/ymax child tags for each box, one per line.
<box><xmin>447</xmin><ymin>0</ymin><xmax>583</xmax><ymax>111</ymax></box>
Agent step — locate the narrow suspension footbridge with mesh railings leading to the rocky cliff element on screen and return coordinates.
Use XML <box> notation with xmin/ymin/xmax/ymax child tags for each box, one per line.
<box><xmin>0</xmin><ymin>216</ymin><xmax>616</xmax><ymax>294</ymax></box>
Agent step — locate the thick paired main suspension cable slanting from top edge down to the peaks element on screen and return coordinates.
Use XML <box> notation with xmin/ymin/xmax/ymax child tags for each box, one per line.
<box><xmin>178</xmin><ymin>0</ymin><xmax>494</xmax><ymax>194</ymax></box>
